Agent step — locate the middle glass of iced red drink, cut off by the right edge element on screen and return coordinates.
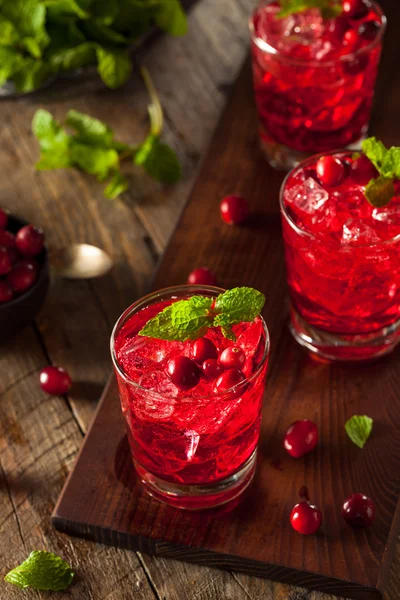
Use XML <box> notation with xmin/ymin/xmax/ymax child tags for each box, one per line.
<box><xmin>281</xmin><ymin>153</ymin><xmax>400</xmax><ymax>360</ymax></box>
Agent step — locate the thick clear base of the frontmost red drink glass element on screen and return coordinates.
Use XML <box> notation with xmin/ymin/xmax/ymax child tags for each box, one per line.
<box><xmin>133</xmin><ymin>450</ymin><xmax>257</xmax><ymax>510</ymax></box>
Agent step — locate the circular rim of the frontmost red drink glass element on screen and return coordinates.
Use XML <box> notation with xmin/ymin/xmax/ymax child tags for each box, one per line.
<box><xmin>110</xmin><ymin>284</ymin><xmax>271</xmax><ymax>402</ymax></box>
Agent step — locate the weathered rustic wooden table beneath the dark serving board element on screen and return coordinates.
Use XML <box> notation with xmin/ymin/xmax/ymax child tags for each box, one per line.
<box><xmin>0</xmin><ymin>0</ymin><xmax>400</xmax><ymax>600</ymax></box>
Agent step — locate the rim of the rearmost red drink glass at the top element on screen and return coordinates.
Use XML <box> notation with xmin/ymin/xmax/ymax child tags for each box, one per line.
<box><xmin>249</xmin><ymin>0</ymin><xmax>387</xmax><ymax>68</ymax></box>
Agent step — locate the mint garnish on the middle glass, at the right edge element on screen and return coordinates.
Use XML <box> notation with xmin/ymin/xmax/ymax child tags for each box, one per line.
<box><xmin>362</xmin><ymin>137</ymin><xmax>400</xmax><ymax>208</ymax></box>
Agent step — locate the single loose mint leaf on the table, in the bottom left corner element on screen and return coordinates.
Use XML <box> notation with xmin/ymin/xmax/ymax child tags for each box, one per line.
<box><xmin>4</xmin><ymin>550</ymin><xmax>75</xmax><ymax>592</ymax></box>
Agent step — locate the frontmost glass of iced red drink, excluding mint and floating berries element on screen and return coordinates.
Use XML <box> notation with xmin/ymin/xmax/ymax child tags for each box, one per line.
<box><xmin>112</xmin><ymin>286</ymin><xmax>269</xmax><ymax>508</ymax></box>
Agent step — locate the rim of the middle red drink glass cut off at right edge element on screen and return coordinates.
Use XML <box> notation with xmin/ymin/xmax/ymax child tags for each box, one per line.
<box><xmin>279</xmin><ymin>149</ymin><xmax>400</xmax><ymax>248</ymax></box>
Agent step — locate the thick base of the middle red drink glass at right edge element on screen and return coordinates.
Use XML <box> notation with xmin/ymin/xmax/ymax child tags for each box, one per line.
<box><xmin>290</xmin><ymin>306</ymin><xmax>400</xmax><ymax>361</ymax></box>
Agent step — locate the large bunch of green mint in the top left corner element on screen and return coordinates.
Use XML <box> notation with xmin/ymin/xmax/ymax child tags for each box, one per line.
<box><xmin>0</xmin><ymin>0</ymin><xmax>187</xmax><ymax>92</ymax></box>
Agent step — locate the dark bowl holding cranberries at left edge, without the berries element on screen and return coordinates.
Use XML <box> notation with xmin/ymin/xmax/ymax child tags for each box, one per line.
<box><xmin>0</xmin><ymin>214</ymin><xmax>50</xmax><ymax>343</ymax></box>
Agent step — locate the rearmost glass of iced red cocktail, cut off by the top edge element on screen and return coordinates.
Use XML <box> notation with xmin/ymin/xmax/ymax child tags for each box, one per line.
<box><xmin>250</xmin><ymin>0</ymin><xmax>386</xmax><ymax>169</ymax></box>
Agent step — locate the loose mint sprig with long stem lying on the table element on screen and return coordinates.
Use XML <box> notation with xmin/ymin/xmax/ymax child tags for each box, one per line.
<box><xmin>32</xmin><ymin>69</ymin><xmax>181</xmax><ymax>199</ymax></box>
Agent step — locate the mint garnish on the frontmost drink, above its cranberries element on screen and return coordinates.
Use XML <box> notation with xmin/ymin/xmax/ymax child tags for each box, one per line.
<box><xmin>139</xmin><ymin>287</ymin><xmax>265</xmax><ymax>342</ymax></box>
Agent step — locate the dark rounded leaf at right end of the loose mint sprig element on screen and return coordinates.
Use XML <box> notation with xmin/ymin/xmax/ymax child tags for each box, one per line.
<box><xmin>134</xmin><ymin>135</ymin><xmax>182</xmax><ymax>184</ymax></box>
